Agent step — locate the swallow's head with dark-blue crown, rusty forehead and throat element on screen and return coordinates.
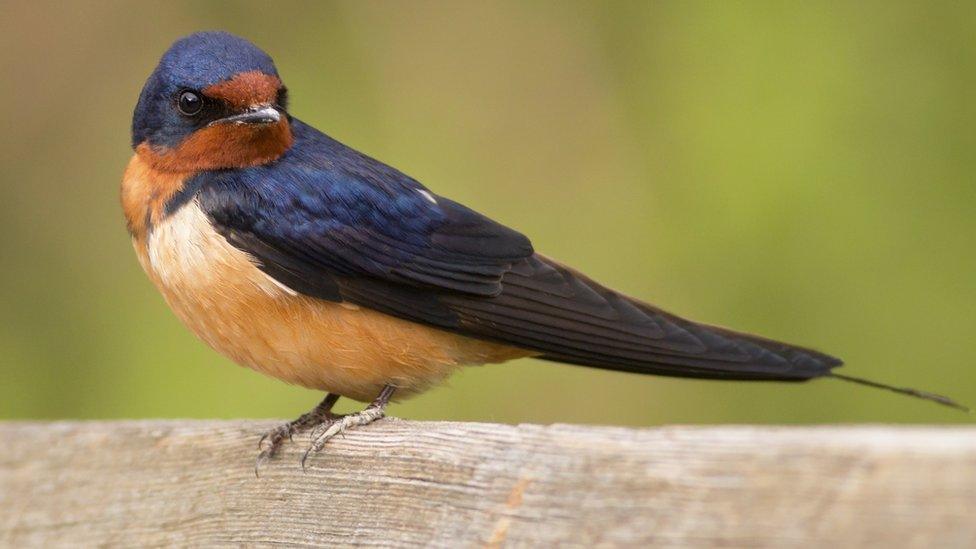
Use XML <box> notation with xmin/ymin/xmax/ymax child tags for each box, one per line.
<box><xmin>132</xmin><ymin>32</ymin><xmax>292</xmax><ymax>172</ymax></box>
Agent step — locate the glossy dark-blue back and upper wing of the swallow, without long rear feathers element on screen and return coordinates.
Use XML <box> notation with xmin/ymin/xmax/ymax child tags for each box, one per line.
<box><xmin>191</xmin><ymin>121</ymin><xmax>533</xmax><ymax>299</ymax></box>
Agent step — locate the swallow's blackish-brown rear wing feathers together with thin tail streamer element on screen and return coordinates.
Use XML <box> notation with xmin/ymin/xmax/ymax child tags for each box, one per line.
<box><xmin>444</xmin><ymin>254</ymin><xmax>969</xmax><ymax>411</ymax></box>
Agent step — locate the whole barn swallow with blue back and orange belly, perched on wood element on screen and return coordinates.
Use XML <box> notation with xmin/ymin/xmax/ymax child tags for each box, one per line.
<box><xmin>121</xmin><ymin>32</ymin><xmax>962</xmax><ymax>464</ymax></box>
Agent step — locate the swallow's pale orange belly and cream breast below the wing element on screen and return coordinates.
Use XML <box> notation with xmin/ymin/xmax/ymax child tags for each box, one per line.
<box><xmin>136</xmin><ymin>199</ymin><xmax>532</xmax><ymax>401</ymax></box>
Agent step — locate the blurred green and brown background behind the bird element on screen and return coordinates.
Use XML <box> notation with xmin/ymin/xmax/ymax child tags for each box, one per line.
<box><xmin>0</xmin><ymin>1</ymin><xmax>976</xmax><ymax>425</ymax></box>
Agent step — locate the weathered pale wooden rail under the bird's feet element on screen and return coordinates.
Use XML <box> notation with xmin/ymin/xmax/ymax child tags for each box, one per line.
<box><xmin>0</xmin><ymin>420</ymin><xmax>976</xmax><ymax>547</ymax></box>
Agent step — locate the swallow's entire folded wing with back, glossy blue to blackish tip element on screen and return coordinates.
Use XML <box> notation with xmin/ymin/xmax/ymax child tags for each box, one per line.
<box><xmin>191</xmin><ymin>120</ymin><xmax>840</xmax><ymax>380</ymax></box>
